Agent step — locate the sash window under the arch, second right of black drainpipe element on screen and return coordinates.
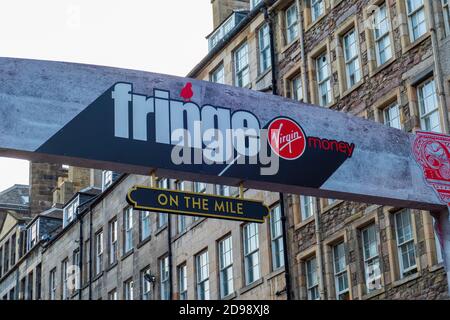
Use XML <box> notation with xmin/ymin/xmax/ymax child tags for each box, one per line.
<box><xmin>333</xmin><ymin>242</ymin><xmax>349</xmax><ymax>300</ymax></box>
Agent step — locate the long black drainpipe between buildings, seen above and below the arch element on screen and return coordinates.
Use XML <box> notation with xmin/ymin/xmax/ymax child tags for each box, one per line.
<box><xmin>263</xmin><ymin>4</ymin><xmax>291</xmax><ymax>300</ymax></box>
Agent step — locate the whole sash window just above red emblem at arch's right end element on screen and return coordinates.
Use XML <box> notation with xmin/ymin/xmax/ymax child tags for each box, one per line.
<box><xmin>417</xmin><ymin>79</ymin><xmax>441</xmax><ymax>132</ymax></box>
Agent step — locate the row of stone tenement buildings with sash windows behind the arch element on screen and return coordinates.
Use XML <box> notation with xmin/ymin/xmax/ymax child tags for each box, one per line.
<box><xmin>0</xmin><ymin>0</ymin><xmax>450</xmax><ymax>299</ymax></box>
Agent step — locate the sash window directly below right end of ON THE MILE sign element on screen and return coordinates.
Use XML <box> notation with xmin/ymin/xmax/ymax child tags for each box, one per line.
<box><xmin>244</xmin><ymin>223</ymin><xmax>261</xmax><ymax>285</ymax></box>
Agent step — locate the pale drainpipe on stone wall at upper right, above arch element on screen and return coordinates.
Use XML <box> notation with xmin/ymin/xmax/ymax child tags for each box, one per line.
<box><xmin>429</xmin><ymin>0</ymin><xmax>449</xmax><ymax>133</ymax></box>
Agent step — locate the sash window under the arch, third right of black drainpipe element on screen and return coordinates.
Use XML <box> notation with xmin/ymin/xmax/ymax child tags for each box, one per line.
<box><xmin>361</xmin><ymin>224</ymin><xmax>381</xmax><ymax>293</ymax></box>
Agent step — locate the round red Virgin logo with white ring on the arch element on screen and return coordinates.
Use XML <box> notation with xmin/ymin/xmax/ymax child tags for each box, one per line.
<box><xmin>268</xmin><ymin>118</ymin><xmax>306</xmax><ymax>160</ymax></box>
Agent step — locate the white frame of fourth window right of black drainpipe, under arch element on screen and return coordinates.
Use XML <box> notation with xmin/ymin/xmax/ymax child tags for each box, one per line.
<box><xmin>394</xmin><ymin>209</ymin><xmax>417</xmax><ymax>279</ymax></box>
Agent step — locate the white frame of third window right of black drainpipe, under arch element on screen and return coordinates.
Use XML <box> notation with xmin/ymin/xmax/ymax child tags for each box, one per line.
<box><xmin>361</xmin><ymin>224</ymin><xmax>381</xmax><ymax>293</ymax></box>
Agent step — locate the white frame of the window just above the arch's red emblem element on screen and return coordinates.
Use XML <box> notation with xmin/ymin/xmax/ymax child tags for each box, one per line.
<box><xmin>417</xmin><ymin>79</ymin><xmax>442</xmax><ymax>132</ymax></box>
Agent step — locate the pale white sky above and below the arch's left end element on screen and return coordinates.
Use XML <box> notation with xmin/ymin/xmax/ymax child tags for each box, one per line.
<box><xmin>0</xmin><ymin>0</ymin><xmax>212</xmax><ymax>191</ymax></box>
